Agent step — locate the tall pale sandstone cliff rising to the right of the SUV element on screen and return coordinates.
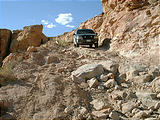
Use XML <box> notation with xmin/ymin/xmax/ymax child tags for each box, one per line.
<box><xmin>57</xmin><ymin>0</ymin><xmax>160</xmax><ymax>64</ymax></box>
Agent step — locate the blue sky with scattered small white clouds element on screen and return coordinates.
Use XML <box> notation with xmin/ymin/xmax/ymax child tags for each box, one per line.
<box><xmin>0</xmin><ymin>0</ymin><xmax>103</xmax><ymax>37</ymax></box>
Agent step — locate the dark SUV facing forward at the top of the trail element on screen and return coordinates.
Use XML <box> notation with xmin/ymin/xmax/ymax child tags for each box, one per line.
<box><xmin>73</xmin><ymin>29</ymin><xmax>98</xmax><ymax>48</ymax></box>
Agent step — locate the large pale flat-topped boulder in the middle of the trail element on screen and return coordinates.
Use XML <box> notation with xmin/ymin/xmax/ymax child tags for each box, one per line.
<box><xmin>72</xmin><ymin>63</ymin><xmax>104</xmax><ymax>80</ymax></box>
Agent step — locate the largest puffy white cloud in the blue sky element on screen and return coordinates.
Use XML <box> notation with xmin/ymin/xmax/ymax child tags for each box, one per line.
<box><xmin>55</xmin><ymin>13</ymin><xmax>73</xmax><ymax>25</ymax></box>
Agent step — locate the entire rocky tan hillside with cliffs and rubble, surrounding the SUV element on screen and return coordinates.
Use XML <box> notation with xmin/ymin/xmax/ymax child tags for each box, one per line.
<box><xmin>0</xmin><ymin>0</ymin><xmax>160</xmax><ymax>120</ymax></box>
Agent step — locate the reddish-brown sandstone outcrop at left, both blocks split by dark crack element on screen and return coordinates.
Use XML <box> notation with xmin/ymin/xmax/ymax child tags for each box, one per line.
<box><xmin>0</xmin><ymin>25</ymin><xmax>48</xmax><ymax>65</ymax></box>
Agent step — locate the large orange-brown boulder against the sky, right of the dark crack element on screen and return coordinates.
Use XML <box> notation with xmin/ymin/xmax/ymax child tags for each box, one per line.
<box><xmin>10</xmin><ymin>25</ymin><xmax>47</xmax><ymax>52</ymax></box>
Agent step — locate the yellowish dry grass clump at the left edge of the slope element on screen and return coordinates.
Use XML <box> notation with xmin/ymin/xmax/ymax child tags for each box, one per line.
<box><xmin>0</xmin><ymin>66</ymin><xmax>16</xmax><ymax>86</ymax></box>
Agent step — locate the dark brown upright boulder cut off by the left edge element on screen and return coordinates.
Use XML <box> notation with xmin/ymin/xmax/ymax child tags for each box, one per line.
<box><xmin>0</xmin><ymin>29</ymin><xmax>12</xmax><ymax>58</ymax></box>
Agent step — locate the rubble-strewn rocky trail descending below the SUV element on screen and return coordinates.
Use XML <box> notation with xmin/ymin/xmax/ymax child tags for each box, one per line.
<box><xmin>0</xmin><ymin>41</ymin><xmax>160</xmax><ymax>120</ymax></box>
